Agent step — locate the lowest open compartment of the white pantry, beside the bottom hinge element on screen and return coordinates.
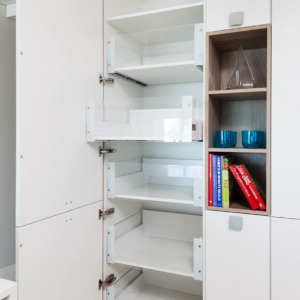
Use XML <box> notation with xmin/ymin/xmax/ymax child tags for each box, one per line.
<box><xmin>106</xmin><ymin>267</ymin><xmax>203</xmax><ymax>300</ymax></box>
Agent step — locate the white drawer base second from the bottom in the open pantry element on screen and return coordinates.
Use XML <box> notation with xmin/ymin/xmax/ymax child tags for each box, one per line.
<box><xmin>115</xmin><ymin>236</ymin><xmax>194</xmax><ymax>278</ymax></box>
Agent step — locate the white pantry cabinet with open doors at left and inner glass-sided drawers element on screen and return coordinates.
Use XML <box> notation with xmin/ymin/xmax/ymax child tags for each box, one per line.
<box><xmin>16</xmin><ymin>0</ymin><xmax>205</xmax><ymax>300</ymax></box>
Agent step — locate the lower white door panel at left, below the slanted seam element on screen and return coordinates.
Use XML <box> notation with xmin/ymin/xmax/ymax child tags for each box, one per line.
<box><xmin>17</xmin><ymin>202</ymin><xmax>102</xmax><ymax>300</ymax></box>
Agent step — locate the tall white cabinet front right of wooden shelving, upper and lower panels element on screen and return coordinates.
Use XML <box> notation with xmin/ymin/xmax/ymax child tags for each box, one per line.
<box><xmin>272</xmin><ymin>0</ymin><xmax>300</xmax><ymax>300</ymax></box>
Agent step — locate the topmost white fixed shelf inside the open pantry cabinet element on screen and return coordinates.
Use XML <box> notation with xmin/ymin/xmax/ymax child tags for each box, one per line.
<box><xmin>107</xmin><ymin>2</ymin><xmax>203</xmax><ymax>33</ymax></box>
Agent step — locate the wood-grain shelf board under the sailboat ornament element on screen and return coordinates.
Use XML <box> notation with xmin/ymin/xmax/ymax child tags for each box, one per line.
<box><xmin>209</xmin><ymin>88</ymin><xmax>267</xmax><ymax>101</ymax></box>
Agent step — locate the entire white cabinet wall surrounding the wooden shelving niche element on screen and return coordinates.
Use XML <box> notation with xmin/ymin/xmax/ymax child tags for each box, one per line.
<box><xmin>12</xmin><ymin>0</ymin><xmax>300</xmax><ymax>300</ymax></box>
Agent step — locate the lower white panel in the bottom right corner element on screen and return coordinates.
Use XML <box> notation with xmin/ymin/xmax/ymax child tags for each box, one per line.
<box><xmin>272</xmin><ymin>218</ymin><xmax>300</xmax><ymax>300</ymax></box>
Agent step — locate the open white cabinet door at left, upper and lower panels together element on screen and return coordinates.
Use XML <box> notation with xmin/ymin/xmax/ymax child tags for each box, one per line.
<box><xmin>16</xmin><ymin>0</ymin><xmax>103</xmax><ymax>300</ymax></box>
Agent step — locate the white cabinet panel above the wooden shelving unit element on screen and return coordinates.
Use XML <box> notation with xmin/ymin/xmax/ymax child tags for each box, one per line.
<box><xmin>206</xmin><ymin>0</ymin><xmax>271</xmax><ymax>31</ymax></box>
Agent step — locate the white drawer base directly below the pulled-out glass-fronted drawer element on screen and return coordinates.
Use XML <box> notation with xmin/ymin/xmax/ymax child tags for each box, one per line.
<box><xmin>115</xmin><ymin>184</ymin><xmax>194</xmax><ymax>205</ymax></box>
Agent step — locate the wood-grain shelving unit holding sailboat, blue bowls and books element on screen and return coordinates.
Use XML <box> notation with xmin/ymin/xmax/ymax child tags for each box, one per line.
<box><xmin>205</xmin><ymin>25</ymin><xmax>271</xmax><ymax>215</ymax></box>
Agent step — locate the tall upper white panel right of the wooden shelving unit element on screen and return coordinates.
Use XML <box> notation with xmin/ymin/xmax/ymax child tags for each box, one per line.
<box><xmin>272</xmin><ymin>0</ymin><xmax>300</xmax><ymax>219</ymax></box>
